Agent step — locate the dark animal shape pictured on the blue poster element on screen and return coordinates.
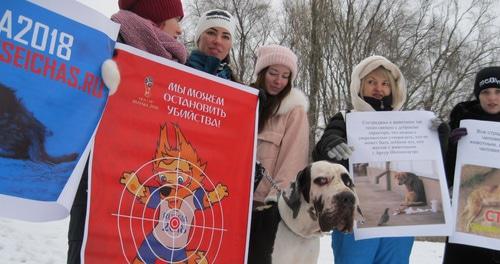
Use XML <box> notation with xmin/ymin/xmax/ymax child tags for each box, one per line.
<box><xmin>0</xmin><ymin>84</ymin><xmax>78</xmax><ymax>164</ymax></box>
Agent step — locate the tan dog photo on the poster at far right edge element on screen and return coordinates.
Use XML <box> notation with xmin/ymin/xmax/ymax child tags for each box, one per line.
<box><xmin>457</xmin><ymin>165</ymin><xmax>500</xmax><ymax>235</ymax></box>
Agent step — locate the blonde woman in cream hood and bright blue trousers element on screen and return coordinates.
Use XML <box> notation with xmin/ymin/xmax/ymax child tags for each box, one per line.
<box><xmin>312</xmin><ymin>56</ymin><xmax>414</xmax><ymax>264</ymax></box>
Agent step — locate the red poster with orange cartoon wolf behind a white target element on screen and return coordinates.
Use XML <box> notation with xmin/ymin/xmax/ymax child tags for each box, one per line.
<box><xmin>83</xmin><ymin>44</ymin><xmax>257</xmax><ymax>263</ymax></box>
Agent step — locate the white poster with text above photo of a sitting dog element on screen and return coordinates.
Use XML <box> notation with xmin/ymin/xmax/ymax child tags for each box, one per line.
<box><xmin>346</xmin><ymin>111</ymin><xmax>451</xmax><ymax>239</ymax></box>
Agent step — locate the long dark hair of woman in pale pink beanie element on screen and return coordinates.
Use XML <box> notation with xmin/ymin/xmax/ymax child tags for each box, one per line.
<box><xmin>250</xmin><ymin>67</ymin><xmax>292</xmax><ymax>133</ymax></box>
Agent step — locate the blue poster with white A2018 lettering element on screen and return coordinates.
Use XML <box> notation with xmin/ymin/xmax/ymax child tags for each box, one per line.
<box><xmin>0</xmin><ymin>0</ymin><xmax>118</xmax><ymax>221</ymax></box>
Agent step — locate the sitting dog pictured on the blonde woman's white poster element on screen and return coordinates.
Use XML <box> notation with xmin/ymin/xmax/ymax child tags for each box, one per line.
<box><xmin>394</xmin><ymin>172</ymin><xmax>427</xmax><ymax>207</ymax></box>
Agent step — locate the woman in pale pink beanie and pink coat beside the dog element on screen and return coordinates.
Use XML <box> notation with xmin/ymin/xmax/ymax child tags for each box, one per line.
<box><xmin>248</xmin><ymin>45</ymin><xmax>309</xmax><ymax>263</ymax></box>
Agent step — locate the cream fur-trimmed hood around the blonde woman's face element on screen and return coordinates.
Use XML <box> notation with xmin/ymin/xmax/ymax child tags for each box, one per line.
<box><xmin>350</xmin><ymin>56</ymin><xmax>406</xmax><ymax>111</ymax></box>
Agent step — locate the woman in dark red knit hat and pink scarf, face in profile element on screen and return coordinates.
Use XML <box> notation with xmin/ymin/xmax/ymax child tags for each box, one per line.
<box><xmin>67</xmin><ymin>0</ymin><xmax>187</xmax><ymax>264</ymax></box>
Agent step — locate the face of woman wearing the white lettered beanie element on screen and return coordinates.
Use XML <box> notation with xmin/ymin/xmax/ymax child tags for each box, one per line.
<box><xmin>198</xmin><ymin>27</ymin><xmax>233</xmax><ymax>60</ymax></box>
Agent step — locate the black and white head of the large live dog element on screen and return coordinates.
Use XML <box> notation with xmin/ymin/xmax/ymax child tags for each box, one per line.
<box><xmin>283</xmin><ymin>161</ymin><xmax>358</xmax><ymax>232</ymax></box>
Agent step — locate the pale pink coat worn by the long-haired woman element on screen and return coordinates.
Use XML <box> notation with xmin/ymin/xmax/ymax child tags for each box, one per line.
<box><xmin>254</xmin><ymin>88</ymin><xmax>309</xmax><ymax>202</ymax></box>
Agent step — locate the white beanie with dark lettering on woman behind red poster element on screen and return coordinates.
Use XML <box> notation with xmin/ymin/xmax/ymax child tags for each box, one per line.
<box><xmin>194</xmin><ymin>9</ymin><xmax>236</xmax><ymax>46</ymax></box>
